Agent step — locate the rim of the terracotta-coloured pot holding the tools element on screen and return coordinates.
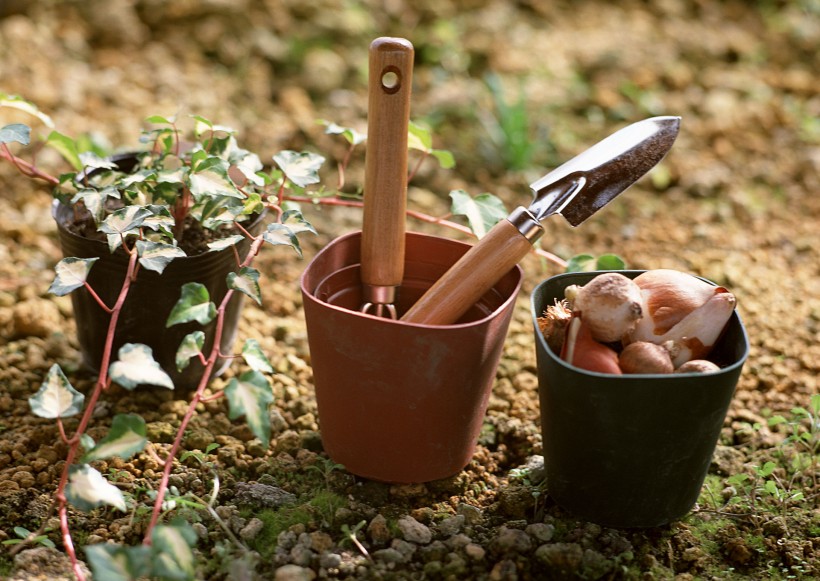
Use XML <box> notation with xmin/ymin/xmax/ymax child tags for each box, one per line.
<box><xmin>299</xmin><ymin>230</ymin><xmax>524</xmax><ymax>330</ymax></box>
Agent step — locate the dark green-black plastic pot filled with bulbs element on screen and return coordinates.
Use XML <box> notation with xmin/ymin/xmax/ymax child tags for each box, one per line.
<box><xmin>532</xmin><ymin>271</ymin><xmax>749</xmax><ymax>528</ymax></box>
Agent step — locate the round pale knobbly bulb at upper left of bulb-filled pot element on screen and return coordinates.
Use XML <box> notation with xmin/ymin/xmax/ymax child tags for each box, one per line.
<box><xmin>572</xmin><ymin>272</ymin><xmax>643</xmax><ymax>343</ymax></box>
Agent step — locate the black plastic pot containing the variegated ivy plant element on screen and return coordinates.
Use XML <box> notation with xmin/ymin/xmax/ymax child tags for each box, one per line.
<box><xmin>52</xmin><ymin>202</ymin><xmax>263</xmax><ymax>390</ymax></box>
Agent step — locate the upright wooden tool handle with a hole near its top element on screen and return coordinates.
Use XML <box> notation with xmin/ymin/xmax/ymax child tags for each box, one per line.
<box><xmin>361</xmin><ymin>37</ymin><xmax>413</xmax><ymax>287</ymax></box>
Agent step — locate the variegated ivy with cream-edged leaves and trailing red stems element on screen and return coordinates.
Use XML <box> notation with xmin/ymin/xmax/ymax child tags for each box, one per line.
<box><xmin>0</xmin><ymin>94</ymin><xmax>324</xmax><ymax>580</ymax></box>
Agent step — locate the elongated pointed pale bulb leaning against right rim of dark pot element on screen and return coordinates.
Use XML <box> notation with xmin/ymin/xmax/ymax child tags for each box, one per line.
<box><xmin>640</xmin><ymin>289</ymin><xmax>737</xmax><ymax>369</ymax></box>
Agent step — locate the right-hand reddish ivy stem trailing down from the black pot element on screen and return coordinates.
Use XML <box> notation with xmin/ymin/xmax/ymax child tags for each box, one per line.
<box><xmin>142</xmin><ymin>236</ymin><xmax>264</xmax><ymax>546</ymax></box>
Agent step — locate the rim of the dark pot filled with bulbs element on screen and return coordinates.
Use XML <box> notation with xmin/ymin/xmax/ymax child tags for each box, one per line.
<box><xmin>530</xmin><ymin>269</ymin><xmax>749</xmax><ymax>378</ymax></box>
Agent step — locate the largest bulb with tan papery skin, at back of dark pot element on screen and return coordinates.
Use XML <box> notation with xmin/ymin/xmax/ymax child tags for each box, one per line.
<box><xmin>630</xmin><ymin>268</ymin><xmax>727</xmax><ymax>343</ymax></box>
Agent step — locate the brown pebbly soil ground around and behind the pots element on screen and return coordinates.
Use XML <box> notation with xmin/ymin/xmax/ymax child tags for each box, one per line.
<box><xmin>0</xmin><ymin>0</ymin><xmax>820</xmax><ymax>580</ymax></box>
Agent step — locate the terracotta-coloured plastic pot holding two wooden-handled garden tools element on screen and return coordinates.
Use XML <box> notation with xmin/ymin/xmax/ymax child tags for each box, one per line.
<box><xmin>301</xmin><ymin>232</ymin><xmax>522</xmax><ymax>483</ymax></box>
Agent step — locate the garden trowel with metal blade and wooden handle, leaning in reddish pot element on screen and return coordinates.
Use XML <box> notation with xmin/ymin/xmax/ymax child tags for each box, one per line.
<box><xmin>401</xmin><ymin>116</ymin><xmax>680</xmax><ymax>325</ymax></box>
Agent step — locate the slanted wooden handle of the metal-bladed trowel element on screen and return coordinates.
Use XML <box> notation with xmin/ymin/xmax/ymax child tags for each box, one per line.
<box><xmin>401</xmin><ymin>220</ymin><xmax>532</xmax><ymax>325</ymax></box>
